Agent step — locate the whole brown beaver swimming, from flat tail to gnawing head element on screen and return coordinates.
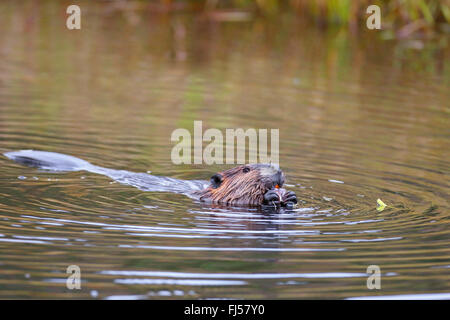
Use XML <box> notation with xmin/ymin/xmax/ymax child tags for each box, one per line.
<box><xmin>4</xmin><ymin>150</ymin><xmax>297</xmax><ymax>207</ymax></box>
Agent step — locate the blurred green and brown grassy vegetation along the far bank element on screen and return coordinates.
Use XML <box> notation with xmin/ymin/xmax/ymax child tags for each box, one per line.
<box><xmin>127</xmin><ymin>0</ymin><xmax>450</xmax><ymax>37</ymax></box>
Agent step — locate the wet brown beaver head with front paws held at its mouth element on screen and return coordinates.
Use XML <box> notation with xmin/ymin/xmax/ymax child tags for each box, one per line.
<box><xmin>195</xmin><ymin>164</ymin><xmax>297</xmax><ymax>205</ymax></box>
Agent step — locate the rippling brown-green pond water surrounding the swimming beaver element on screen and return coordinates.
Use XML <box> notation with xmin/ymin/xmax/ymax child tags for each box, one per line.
<box><xmin>0</xmin><ymin>1</ymin><xmax>450</xmax><ymax>299</ymax></box>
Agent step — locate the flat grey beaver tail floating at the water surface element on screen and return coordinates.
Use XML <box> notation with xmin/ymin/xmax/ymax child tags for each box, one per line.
<box><xmin>4</xmin><ymin>150</ymin><xmax>95</xmax><ymax>171</ymax></box>
